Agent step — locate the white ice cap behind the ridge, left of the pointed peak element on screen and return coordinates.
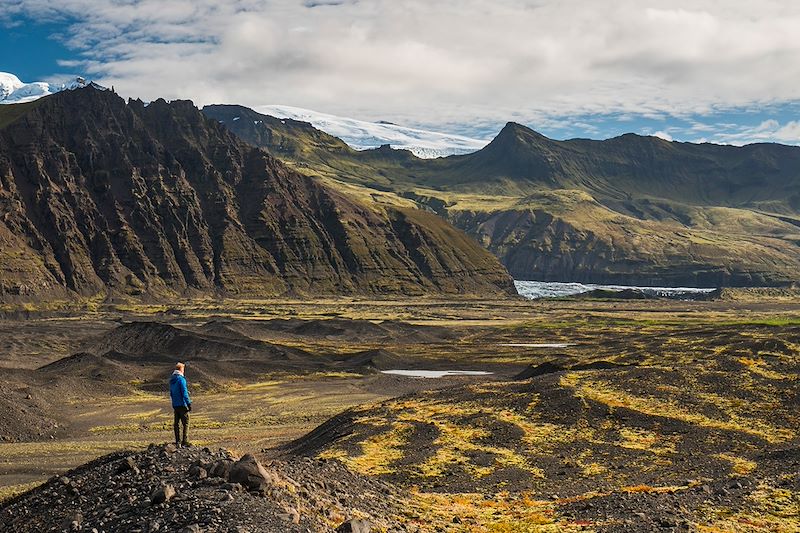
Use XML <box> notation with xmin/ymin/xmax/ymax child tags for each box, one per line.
<box><xmin>254</xmin><ymin>105</ymin><xmax>489</xmax><ymax>158</ymax></box>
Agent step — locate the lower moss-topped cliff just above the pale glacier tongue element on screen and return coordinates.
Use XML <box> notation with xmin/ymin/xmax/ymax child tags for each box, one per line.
<box><xmin>448</xmin><ymin>208</ymin><xmax>800</xmax><ymax>287</ymax></box>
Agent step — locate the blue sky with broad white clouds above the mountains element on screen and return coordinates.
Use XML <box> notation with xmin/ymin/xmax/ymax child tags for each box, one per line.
<box><xmin>0</xmin><ymin>0</ymin><xmax>800</xmax><ymax>144</ymax></box>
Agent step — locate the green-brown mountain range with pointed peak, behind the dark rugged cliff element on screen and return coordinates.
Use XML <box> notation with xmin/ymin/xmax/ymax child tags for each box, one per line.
<box><xmin>203</xmin><ymin>106</ymin><xmax>800</xmax><ymax>287</ymax></box>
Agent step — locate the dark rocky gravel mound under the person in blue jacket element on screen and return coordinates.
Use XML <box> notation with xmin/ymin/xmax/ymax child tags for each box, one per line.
<box><xmin>0</xmin><ymin>444</ymin><xmax>406</xmax><ymax>533</ymax></box>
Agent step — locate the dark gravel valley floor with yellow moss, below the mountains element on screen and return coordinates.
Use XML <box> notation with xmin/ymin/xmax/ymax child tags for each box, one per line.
<box><xmin>0</xmin><ymin>294</ymin><xmax>800</xmax><ymax>532</ymax></box>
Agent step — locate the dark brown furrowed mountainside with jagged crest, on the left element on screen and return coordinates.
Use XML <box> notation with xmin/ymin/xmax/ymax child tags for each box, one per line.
<box><xmin>0</xmin><ymin>88</ymin><xmax>511</xmax><ymax>297</ymax></box>
